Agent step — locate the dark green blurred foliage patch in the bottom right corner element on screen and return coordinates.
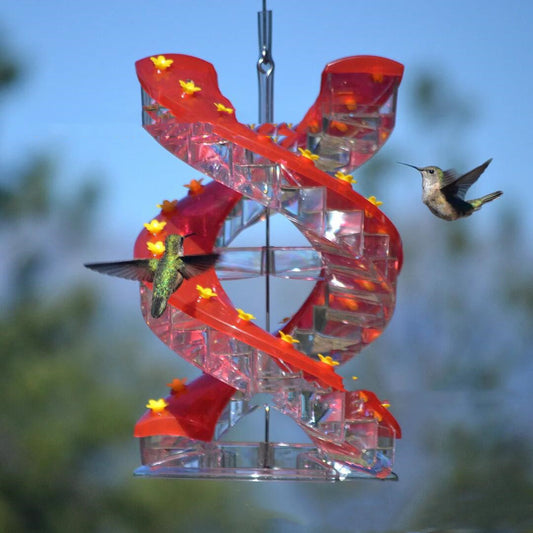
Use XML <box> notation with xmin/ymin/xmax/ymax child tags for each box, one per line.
<box><xmin>411</xmin><ymin>424</ymin><xmax>533</xmax><ymax>532</ymax></box>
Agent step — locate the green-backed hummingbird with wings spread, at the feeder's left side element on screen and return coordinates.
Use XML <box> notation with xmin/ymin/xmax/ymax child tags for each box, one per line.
<box><xmin>84</xmin><ymin>234</ymin><xmax>219</xmax><ymax>318</ymax></box>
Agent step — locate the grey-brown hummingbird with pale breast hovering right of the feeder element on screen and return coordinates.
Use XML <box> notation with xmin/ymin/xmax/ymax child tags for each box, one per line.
<box><xmin>400</xmin><ymin>159</ymin><xmax>503</xmax><ymax>220</ymax></box>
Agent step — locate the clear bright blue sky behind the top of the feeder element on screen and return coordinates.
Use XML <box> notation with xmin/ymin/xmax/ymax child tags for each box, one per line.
<box><xmin>0</xmin><ymin>0</ymin><xmax>533</xmax><ymax>250</ymax></box>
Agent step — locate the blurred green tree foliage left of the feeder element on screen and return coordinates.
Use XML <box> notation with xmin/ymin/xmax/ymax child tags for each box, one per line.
<box><xmin>0</xmin><ymin>40</ymin><xmax>282</xmax><ymax>533</ymax></box>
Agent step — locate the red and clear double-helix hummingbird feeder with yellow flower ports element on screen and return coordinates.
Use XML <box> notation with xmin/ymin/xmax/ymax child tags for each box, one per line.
<box><xmin>124</xmin><ymin>4</ymin><xmax>403</xmax><ymax>481</ymax></box>
